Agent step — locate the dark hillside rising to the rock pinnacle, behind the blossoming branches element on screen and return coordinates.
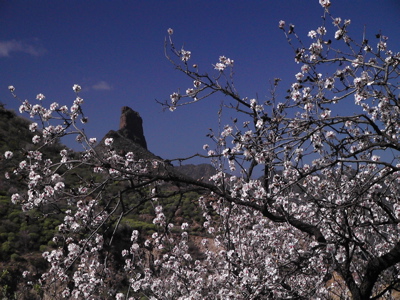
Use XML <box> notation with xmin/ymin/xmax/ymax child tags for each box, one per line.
<box><xmin>0</xmin><ymin>105</ymin><xmax>214</xmax><ymax>299</ymax></box>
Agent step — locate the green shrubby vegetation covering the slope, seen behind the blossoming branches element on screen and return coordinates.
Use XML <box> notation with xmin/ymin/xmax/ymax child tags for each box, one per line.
<box><xmin>0</xmin><ymin>103</ymin><xmax>208</xmax><ymax>299</ymax></box>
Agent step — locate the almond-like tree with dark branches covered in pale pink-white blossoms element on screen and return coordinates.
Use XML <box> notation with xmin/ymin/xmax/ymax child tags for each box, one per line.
<box><xmin>5</xmin><ymin>0</ymin><xmax>400</xmax><ymax>299</ymax></box>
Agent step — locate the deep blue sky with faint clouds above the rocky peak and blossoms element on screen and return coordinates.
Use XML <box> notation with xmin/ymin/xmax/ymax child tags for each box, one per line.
<box><xmin>0</xmin><ymin>0</ymin><xmax>400</xmax><ymax>163</ymax></box>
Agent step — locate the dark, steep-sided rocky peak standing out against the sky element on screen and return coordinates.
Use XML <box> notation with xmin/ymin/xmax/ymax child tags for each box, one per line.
<box><xmin>118</xmin><ymin>106</ymin><xmax>147</xmax><ymax>150</ymax></box>
